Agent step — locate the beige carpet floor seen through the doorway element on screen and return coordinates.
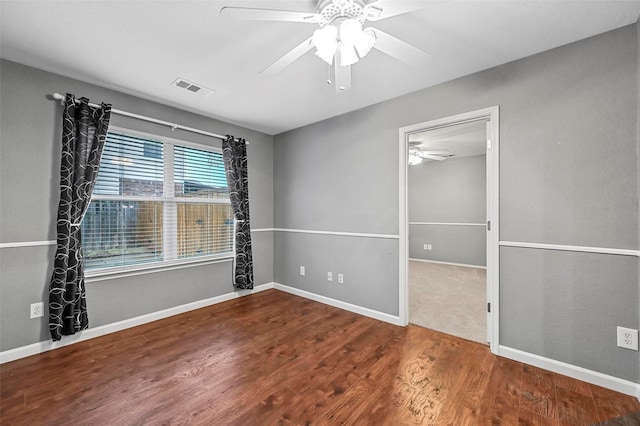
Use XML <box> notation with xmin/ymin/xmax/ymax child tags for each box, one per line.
<box><xmin>409</xmin><ymin>260</ymin><xmax>487</xmax><ymax>344</ymax></box>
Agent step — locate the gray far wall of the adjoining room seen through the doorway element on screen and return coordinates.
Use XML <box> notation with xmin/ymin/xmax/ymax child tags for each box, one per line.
<box><xmin>407</xmin><ymin>155</ymin><xmax>487</xmax><ymax>266</ymax></box>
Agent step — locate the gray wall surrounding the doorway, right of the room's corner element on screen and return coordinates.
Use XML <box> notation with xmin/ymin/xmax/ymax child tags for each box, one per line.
<box><xmin>274</xmin><ymin>25</ymin><xmax>639</xmax><ymax>381</ymax></box>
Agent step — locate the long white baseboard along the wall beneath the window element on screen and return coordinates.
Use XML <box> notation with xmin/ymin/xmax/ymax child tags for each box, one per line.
<box><xmin>0</xmin><ymin>283</ymin><xmax>274</xmax><ymax>364</ymax></box>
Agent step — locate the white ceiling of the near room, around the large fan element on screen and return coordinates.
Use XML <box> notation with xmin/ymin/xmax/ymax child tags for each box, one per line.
<box><xmin>0</xmin><ymin>0</ymin><xmax>640</xmax><ymax>134</ymax></box>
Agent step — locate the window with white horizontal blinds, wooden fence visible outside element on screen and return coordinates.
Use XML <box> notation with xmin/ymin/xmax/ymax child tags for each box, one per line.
<box><xmin>82</xmin><ymin>131</ymin><xmax>233</xmax><ymax>271</ymax></box>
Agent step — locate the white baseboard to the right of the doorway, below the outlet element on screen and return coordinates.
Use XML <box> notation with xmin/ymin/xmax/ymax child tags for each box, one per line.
<box><xmin>499</xmin><ymin>346</ymin><xmax>640</xmax><ymax>400</ymax></box>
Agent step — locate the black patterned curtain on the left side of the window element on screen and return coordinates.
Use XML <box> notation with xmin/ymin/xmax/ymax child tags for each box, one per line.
<box><xmin>49</xmin><ymin>93</ymin><xmax>111</xmax><ymax>340</ymax></box>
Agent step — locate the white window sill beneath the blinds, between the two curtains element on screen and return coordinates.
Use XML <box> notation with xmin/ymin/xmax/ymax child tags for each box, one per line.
<box><xmin>84</xmin><ymin>253</ymin><xmax>233</xmax><ymax>283</ymax></box>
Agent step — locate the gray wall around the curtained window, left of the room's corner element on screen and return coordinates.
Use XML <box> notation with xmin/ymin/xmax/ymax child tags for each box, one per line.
<box><xmin>0</xmin><ymin>60</ymin><xmax>273</xmax><ymax>351</ymax></box>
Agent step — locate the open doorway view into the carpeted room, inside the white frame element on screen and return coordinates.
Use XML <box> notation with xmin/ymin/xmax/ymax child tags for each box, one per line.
<box><xmin>407</xmin><ymin>119</ymin><xmax>487</xmax><ymax>344</ymax></box>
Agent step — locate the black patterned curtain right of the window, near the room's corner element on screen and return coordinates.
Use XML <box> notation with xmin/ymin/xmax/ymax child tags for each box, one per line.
<box><xmin>222</xmin><ymin>135</ymin><xmax>253</xmax><ymax>290</ymax></box>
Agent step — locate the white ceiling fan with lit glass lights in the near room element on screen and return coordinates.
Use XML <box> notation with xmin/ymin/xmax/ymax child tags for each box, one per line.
<box><xmin>220</xmin><ymin>0</ymin><xmax>429</xmax><ymax>93</ymax></box>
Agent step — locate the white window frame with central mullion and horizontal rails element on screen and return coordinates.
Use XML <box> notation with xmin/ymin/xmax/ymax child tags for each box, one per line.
<box><xmin>83</xmin><ymin>126</ymin><xmax>234</xmax><ymax>281</ymax></box>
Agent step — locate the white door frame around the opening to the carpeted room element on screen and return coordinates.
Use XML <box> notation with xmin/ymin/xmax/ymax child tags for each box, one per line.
<box><xmin>398</xmin><ymin>105</ymin><xmax>500</xmax><ymax>355</ymax></box>
